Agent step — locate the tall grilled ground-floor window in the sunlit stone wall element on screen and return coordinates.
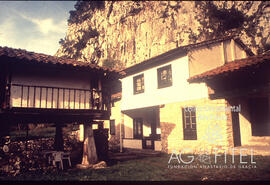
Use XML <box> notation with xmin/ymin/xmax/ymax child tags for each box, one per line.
<box><xmin>182</xmin><ymin>107</ymin><xmax>197</xmax><ymax>140</ymax></box>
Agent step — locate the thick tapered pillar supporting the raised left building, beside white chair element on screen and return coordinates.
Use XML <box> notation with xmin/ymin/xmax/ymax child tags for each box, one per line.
<box><xmin>82</xmin><ymin>124</ymin><xmax>98</xmax><ymax>166</ymax></box>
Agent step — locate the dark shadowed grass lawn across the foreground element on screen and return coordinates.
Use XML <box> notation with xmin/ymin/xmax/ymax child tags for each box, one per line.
<box><xmin>1</xmin><ymin>154</ymin><xmax>270</xmax><ymax>181</ymax></box>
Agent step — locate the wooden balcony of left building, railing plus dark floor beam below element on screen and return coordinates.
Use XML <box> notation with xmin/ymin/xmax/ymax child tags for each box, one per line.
<box><xmin>2</xmin><ymin>84</ymin><xmax>110</xmax><ymax>122</ymax></box>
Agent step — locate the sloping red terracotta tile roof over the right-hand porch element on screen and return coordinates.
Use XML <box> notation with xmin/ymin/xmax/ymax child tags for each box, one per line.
<box><xmin>188</xmin><ymin>51</ymin><xmax>270</xmax><ymax>83</ymax></box>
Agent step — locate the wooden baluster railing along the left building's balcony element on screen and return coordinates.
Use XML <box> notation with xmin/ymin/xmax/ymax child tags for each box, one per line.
<box><xmin>8</xmin><ymin>84</ymin><xmax>108</xmax><ymax>110</ymax></box>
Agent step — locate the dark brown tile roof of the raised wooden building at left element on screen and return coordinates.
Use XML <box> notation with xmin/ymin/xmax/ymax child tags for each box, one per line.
<box><xmin>0</xmin><ymin>46</ymin><xmax>121</xmax><ymax>72</ymax></box>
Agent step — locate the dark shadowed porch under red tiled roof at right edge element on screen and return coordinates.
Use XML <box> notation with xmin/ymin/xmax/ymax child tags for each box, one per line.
<box><xmin>189</xmin><ymin>52</ymin><xmax>270</xmax><ymax>148</ymax></box>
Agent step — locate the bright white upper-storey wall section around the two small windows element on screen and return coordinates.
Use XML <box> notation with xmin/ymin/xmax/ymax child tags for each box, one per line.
<box><xmin>121</xmin><ymin>56</ymin><xmax>208</xmax><ymax>110</ymax></box>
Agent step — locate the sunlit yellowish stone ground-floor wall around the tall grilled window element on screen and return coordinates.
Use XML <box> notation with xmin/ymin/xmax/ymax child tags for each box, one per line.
<box><xmin>160</xmin><ymin>98</ymin><xmax>233</xmax><ymax>153</ymax></box>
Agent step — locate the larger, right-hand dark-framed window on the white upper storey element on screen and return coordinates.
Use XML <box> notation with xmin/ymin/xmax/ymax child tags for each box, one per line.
<box><xmin>157</xmin><ymin>65</ymin><xmax>172</xmax><ymax>89</ymax></box>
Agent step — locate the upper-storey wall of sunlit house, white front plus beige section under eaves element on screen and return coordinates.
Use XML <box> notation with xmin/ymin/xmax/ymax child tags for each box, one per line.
<box><xmin>121</xmin><ymin>40</ymin><xmax>250</xmax><ymax>110</ymax></box>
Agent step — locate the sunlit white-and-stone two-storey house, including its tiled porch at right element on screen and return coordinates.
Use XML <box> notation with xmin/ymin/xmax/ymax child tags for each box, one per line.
<box><xmin>107</xmin><ymin>36</ymin><xmax>270</xmax><ymax>152</ymax></box>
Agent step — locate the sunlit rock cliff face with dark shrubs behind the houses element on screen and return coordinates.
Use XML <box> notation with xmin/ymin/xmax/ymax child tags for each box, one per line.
<box><xmin>56</xmin><ymin>1</ymin><xmax>270</xmax><ymax>67</ymax></box>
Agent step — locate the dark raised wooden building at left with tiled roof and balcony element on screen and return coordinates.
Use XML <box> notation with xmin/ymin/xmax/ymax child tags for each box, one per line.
<box><xmin>0</xmin><ymin>47</ymin><xmax>119</xmax><ymax>165</ymax></box>
